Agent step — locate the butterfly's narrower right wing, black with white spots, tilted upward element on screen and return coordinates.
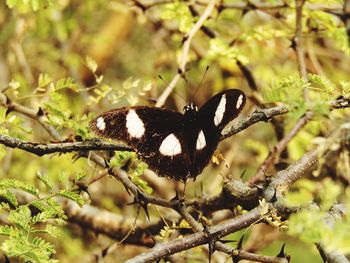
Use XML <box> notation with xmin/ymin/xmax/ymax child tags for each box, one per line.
<box><xmin>191</xmin><ymin>89</ymin><xmax>246</xmax><ymax>176</ymax></box>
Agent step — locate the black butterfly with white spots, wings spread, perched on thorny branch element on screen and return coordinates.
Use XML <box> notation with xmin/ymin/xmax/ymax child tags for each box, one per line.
<box><xmin>90</xmin><ymin>89</ymin><xmax>246</xmax><ymax>181</ymax></box>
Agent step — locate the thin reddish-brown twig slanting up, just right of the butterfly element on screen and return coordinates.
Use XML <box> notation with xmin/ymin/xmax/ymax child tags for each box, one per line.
<box><xmin>248</xmin><ymin>112</ymin><xmax>313</xmax><ymax>184</ymax></box>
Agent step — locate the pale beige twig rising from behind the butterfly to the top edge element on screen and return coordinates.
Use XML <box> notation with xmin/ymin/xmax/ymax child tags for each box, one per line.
<box><xmin>156</xmin><ymin>0</ymin><xmax>216</xmax><ymax>107</ymax></box>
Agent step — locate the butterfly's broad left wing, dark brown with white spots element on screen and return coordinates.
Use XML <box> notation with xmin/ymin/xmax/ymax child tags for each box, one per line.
<box><xmin>90</xmin><ymin>107</ymin><xmax>191</xmax><ymax>181</ymax></box>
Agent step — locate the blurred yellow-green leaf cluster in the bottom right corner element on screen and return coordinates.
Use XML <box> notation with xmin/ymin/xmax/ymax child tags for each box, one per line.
<box><xmin>286</xmin><ymin>178</ymin><xmax>350</xmax><ymax>254</ymax></box>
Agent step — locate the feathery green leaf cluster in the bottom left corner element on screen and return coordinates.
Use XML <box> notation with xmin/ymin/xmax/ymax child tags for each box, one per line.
<box><xmin>0</xmin><ymin>173</ymin><xmax>85</xmax><ymax>262</ymax></box>
